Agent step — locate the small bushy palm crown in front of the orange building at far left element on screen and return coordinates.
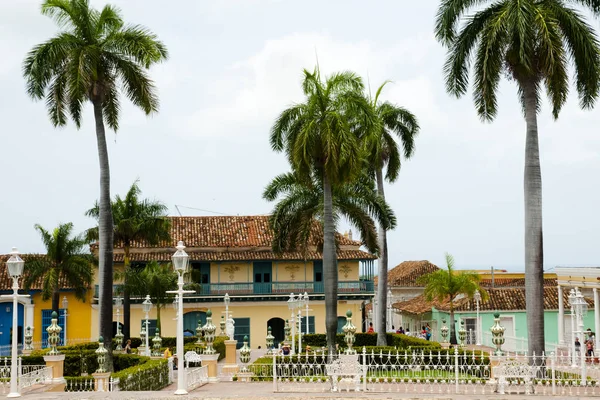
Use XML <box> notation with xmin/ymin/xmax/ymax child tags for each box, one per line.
<box><xmin>23</xmin><ymin>223</ymin><xmax>94</xmax><ymax>313</ymax></box>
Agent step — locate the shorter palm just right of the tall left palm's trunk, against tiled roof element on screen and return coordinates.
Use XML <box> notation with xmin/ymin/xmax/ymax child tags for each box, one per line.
<box><xmin>86</xmin><ymin>181</ymin><xmax>171</xmax><ymax>340</ymax></box>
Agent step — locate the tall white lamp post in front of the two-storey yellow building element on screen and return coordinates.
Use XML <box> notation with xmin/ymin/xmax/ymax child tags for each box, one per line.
<box><xmin>167</xmin><ymin>240</ymin><xmax>195</xmax><ymax>395</ymax></box>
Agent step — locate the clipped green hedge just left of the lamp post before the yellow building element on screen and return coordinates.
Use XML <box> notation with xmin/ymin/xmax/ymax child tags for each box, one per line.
<box><xmin>111</xmin><ymin>358</ymin><xmax>169</xmax><ymax>391</ymax></box>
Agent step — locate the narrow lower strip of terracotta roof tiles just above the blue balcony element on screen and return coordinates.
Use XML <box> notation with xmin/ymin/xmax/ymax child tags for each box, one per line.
<box><xmin>113</xmin><ymin>250</ymin><xmax>377</xmax><ymax>263</ymax></box>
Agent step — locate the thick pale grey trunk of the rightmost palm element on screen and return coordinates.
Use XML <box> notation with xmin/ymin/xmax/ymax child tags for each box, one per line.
<box><xmin>521</xmin><ymin>80</ymin><xmax>545</xmax><ymax>354</ymax></box>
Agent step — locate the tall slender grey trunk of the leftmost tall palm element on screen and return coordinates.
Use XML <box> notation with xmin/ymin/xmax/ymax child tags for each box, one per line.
<box><xmin>93</xmin><ymin>100</ymin><xmax>113</xmax><ymax>371</ymax></box>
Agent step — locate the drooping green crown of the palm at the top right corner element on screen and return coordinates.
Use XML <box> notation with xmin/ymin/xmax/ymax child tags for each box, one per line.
<box><xmin>435</xmin><ymin>0</ymin><xmax>600</xmax><ymax>120</ymax></box>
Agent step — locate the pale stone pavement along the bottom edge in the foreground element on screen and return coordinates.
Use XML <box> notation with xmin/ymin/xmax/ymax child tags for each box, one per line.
<box><xmin>16</xmin><ymin>382</ymin><xmax>598</xmax><ymax>400</ymax></box>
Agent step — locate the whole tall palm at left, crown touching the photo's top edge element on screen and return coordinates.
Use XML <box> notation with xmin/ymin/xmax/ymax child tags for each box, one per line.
<box><xmin>23</xmin><ymin>0</ymin><xmax>167</xmax><ymax>348</ymax></box>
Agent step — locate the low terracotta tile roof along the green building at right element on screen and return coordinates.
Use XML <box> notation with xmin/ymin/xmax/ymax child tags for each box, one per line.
<box><xmin>392</xmin><ymin>286</ymin><xmax>594</xmax><ymax>314</ymax></box>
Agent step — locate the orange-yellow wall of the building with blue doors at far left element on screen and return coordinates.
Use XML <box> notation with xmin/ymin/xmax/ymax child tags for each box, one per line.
<box><xmin>32</xmin><ymin>291</ymin><xmax>97</xmax><ymax>343</ymax></box>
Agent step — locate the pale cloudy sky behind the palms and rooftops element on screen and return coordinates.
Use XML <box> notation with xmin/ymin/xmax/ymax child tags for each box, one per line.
<box><xmin>0</xmin><ymin>0</ymin><xmax>600</xmax><ymax>270</ymax></box>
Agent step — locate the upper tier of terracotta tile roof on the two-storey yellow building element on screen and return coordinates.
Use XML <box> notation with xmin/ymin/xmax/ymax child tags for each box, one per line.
<box><xmin>110</xmin><ymin>215</ymin><xmax>361</xmax><ymax>248</ymax></box>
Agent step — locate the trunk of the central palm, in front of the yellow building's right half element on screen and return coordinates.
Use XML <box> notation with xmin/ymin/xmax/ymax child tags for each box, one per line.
<box><xmin>323</xmin><ymin>172</ymin><xmax>338</xmax><ymax>356</ymax></box>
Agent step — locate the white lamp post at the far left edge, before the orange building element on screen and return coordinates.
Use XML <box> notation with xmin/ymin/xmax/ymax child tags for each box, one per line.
<box><xmin>1</xmin><ymin>247</ymin><xmax>29</xmax><ymax>397</ymax></box>
